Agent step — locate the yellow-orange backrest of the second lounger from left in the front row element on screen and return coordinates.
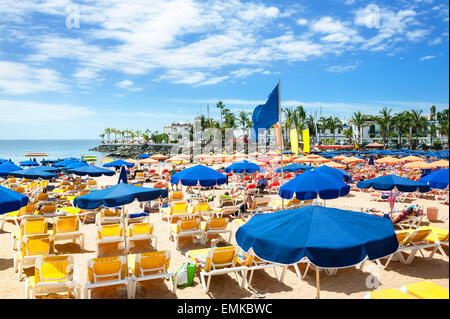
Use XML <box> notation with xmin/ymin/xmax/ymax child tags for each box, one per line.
<box><xmin>88</xmin><ymin>256</ymin><xmax>128</xmax><ymax>282</ymax></box>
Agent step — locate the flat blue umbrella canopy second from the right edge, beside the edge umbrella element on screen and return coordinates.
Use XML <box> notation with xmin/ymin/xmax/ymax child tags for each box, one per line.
<box><xmin>356</xmin><ymin>175</ymin><xmax>430</xmax><ymax>193</ymax></box>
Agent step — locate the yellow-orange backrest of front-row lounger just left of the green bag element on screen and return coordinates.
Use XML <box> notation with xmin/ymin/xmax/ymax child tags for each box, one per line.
<box><xmin>135</xmin><ymin>250</ymin><xmax>170</xmax><ymax>276</ymax></box>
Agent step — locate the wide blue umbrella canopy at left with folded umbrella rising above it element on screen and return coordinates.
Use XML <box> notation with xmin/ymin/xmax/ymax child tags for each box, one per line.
<box><xmin>73</xmin><ymin>184</ymin><xmax>168</xmax><ymax>209</ymax></box>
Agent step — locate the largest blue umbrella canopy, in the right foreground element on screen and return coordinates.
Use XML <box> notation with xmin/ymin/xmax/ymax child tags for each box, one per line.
<box><xmin>236</xmin><ymin>205</ymin><xmax>398</xmax><ymax>268</ymax></box>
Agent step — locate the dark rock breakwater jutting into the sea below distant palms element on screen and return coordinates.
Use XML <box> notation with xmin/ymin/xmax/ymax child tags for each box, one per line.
<box><xmin>90</xmin><ymin>144</ymin><xmax>178</xmax><ymax>157</ymax></box>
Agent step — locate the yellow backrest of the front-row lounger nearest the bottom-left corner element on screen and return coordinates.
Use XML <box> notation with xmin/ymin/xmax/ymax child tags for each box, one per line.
<box><xmin>34</xmin><ymin>255</ymin><xmax>73</xmax><ymax>282</ymax></box>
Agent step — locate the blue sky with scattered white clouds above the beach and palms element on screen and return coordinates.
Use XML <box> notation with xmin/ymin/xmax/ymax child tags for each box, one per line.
<box><xmin>0</xmin><ymin>0</ymin><xmax>449</xmax><ymax>138</ymax></box>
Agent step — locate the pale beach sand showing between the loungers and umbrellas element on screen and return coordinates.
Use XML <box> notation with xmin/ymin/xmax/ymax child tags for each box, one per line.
<box><xmin>0</xmin><ymin>172</ymin><xmax>449</xmax><ymax>299</ymax></box>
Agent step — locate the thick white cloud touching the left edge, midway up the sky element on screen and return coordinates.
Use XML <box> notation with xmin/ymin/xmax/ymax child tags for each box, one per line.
<box><xmin>0</xmin><ymin>61</ymin><xmax>68</xmax><ymax>94</ymax></box>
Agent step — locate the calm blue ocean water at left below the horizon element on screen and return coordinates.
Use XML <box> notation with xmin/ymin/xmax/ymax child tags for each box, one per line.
<box><xmin>0</xmin><ymin>140</ymin><xmax>106</xmax><ymax>164</ymax></box>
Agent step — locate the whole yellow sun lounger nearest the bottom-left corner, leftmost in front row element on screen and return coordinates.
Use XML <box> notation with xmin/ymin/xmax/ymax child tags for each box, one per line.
<box><xmin>25</xmin><ymin>255</ymin><xmax>80</xmax><ymax>299</ymax></box>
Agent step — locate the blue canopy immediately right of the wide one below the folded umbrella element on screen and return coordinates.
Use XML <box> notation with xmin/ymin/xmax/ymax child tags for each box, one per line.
<box><xmin>170</xmin><ymin>165</ymin><xmax>227</xmax><ymax>187</ymax></box>
